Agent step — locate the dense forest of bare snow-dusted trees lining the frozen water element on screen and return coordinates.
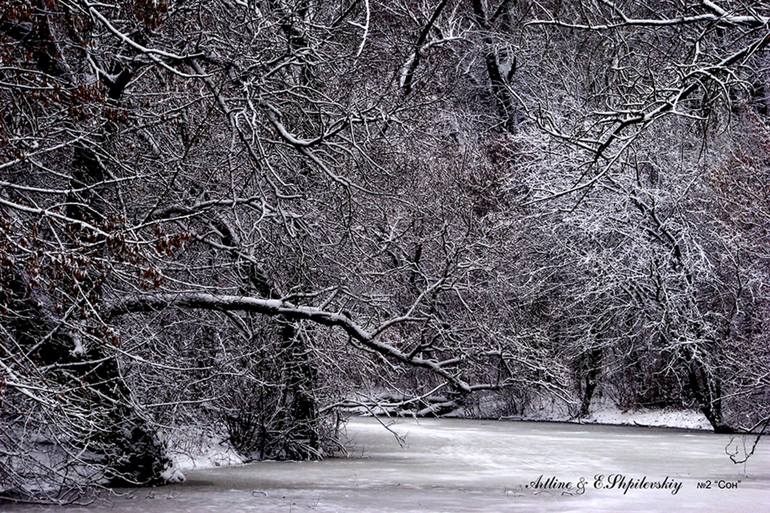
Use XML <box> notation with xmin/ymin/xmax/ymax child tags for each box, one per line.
<box><xmin>0</xmin><ymin>0</ymin><xmax>770</xmax><ymax>501</ymax></box>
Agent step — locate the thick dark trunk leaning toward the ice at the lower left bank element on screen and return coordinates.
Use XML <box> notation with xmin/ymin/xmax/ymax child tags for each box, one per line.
<box><xmin>2</xmin><ymin>258</ymin><xmax>170</xmax><ymax>485</ymax></box>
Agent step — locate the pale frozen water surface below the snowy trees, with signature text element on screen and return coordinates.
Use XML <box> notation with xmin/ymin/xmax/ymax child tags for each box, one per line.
<box><xmin>6</xmin><ymin>418</ymin><xmax>770</xmax><ymax>513</ymax></box>
